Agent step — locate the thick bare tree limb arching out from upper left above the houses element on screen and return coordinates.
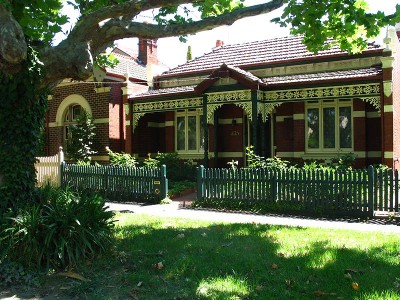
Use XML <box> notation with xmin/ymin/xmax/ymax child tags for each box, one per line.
<box><xmin>40</xmin><ymin>0</ymin><xmax>286</xmax><ymax>84</ymax></box>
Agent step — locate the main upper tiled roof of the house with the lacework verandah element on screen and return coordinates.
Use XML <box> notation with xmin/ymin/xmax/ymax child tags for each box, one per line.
<box><xmin>161</xmin><ymin>36</ymin><xmax>383</xmax><ymax>77</ymax></box>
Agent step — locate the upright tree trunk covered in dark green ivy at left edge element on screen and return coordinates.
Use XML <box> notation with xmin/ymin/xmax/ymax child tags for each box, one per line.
<box><xmin>0</xmin><ymin>59</ymin><xmax>46</xmax><ymax>215</ymax></box>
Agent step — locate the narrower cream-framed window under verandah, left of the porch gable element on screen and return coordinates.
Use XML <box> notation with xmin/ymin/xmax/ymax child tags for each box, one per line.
<box><xmin>175</xmin><ymin>109</ymin><xmax>204</xmax><ymax>153</ymax></box>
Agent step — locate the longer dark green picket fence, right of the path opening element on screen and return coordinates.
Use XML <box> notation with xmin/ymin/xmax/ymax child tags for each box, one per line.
<box><xmin>197</xmin><ymin>166</ymin><xmax>399</xmax><ymax>216</ymax></box>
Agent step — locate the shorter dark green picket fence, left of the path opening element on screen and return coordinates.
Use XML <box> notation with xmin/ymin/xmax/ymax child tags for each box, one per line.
<box><xmin>61</xmin><ymin>164</ymin><xmax>168</xmax><ymax>202</ymax></box>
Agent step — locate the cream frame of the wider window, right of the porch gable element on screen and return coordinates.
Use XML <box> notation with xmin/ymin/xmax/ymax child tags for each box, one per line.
<box><xmin>304</xmin><ymin>99</ymin><xmax>354</xmax><ymax>153</ymax></box>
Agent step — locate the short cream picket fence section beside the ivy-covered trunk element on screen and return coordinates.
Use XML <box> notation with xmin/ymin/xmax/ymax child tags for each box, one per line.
<box><xmin>35</xmin><ymin>147</ymin><xmax>64</xmax><ymax>187</ymax></box>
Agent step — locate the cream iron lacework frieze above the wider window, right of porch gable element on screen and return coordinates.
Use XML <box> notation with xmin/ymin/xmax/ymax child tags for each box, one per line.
<box><xmin>264</xmin><ymin>83</ymin><xmax>380</xmax><ymax>101</ymax></box>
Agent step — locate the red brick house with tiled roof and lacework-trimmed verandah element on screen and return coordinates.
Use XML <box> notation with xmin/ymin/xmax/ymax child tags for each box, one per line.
<box><xmin>125</xmin><ymin>30</ymin><xmax>400</xmax><ymax>168</ymax></box>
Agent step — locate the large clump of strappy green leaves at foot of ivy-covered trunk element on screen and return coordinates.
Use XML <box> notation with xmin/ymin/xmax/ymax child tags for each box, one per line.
<box><xmin>6</xmin><ymin>186</ymin><xmax>113</xmax><ymax>269</ymax></box>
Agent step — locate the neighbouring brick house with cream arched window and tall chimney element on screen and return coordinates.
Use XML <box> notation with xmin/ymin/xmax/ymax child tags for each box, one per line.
<box><xmin>45</xmin><ymin>39</ymin><xmax>166</xmax><ymax>161</ymax></box>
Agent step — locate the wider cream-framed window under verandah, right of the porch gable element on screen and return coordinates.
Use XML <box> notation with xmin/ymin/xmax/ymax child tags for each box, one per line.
<box><xmin>306</xmin><ymin>99</ymin><xmax>353</xmax><ymax>152</ymax></box>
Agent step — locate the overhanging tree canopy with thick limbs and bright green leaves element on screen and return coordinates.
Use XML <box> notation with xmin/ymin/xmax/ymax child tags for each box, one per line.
<box><xmin>0</xmin><ymin>0</ymin><xmax>400</xmax><ymax>85</ymax></box>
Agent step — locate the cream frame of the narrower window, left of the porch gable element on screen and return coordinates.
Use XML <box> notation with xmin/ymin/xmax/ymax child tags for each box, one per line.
<box><xmin>175</xmin><ymin>109</ymin><xmax>204</xmax><ymax>154</ymax></box>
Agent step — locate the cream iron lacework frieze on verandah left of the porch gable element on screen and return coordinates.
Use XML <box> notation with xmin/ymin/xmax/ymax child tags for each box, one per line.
<box><xmin>132</xmin><ymin>98</ymin><xmax>203</xmax><ymax>114</ymax></box>
